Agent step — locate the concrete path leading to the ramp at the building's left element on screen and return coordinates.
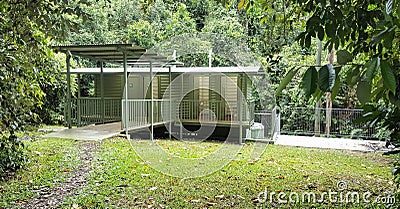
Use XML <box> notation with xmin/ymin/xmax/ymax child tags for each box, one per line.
<box><xmin>43</xmin><ymin>122</ymin><xmax>121</xmax><ymax>140</ymax></box>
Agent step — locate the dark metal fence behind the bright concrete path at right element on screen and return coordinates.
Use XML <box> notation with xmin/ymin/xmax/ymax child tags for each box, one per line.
<box><xmin>280</xmin><ymin>107</ymin><xmax>375</xmax><ymax>138</ymax></box>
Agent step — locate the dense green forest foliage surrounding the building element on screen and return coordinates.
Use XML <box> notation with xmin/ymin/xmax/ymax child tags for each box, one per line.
<box><xmin>0</xmin><ymin>0</ymin><xmax>400</xmax><ymax>186</ymax></box>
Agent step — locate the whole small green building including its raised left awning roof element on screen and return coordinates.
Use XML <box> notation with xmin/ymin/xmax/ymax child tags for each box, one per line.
<box><xmin>54</xmin><ymin>44</ymin><xmax>272</xmax><ymax>143</ymax></box>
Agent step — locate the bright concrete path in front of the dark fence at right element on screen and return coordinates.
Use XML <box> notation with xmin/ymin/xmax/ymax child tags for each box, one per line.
<box><xmin>275</xmin><ymin>135</ymin><xmax>389</xmax><ymax>152</ymax></box>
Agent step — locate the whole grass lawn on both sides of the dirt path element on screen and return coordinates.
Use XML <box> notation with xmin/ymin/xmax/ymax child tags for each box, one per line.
<box><xmin>0</xmin><ymin>138</ymin><xmax>395</xmax><ymax>208</ymax></box>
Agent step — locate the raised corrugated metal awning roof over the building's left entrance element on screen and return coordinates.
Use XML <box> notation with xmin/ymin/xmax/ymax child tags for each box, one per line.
<box><xmin>53</xmin><ymin>44</ymin><xmax>168</xmax><ymax>65</ymax></box>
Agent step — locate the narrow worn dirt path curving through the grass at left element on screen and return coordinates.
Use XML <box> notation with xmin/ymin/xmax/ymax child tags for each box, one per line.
<box><xmin>22</xmin><ymin>141</ymin><xmax>100</xmax><ymax>208</ymax></box>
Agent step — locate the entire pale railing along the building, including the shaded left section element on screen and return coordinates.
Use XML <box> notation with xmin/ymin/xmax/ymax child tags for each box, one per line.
<box><xmin>72</xmin><ymin>97</ymin><xmax>253</xmax><ymax>129</ymax></box>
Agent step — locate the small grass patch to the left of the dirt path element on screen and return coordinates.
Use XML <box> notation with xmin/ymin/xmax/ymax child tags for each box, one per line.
<box><xmin>0</xmin><ymin>137</ymin><xmax>79</xmax><ymax>208</ymax></box>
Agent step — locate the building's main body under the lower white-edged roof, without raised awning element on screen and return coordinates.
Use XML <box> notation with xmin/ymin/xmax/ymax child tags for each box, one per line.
<box><xmin>70</xmin><ymin>67</ymin><xmax>259</xmax><ymax>142</ymax></box>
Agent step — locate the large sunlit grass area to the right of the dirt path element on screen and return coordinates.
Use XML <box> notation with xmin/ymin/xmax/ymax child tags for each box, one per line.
<box><xmin>64</xmin><ymin>138</ymin><xmax>394</xmax><ymax>208</ymax></box>
